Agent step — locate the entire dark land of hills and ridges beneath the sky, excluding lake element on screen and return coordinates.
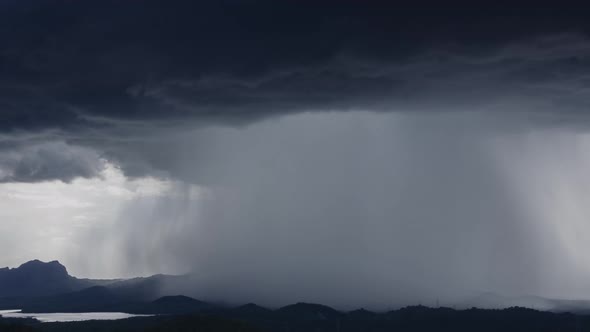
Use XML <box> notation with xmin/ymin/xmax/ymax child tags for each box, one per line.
<box><xmin>0</xmin><ymin>261</ymin><xmax>590</xmax><ymax>332</ymax></box>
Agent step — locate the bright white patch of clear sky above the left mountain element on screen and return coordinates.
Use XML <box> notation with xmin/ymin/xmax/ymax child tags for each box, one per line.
<box><xmin>0</xmin><ymin>164</ymin><xmax>172</xmax><ymax>277</ymax></box>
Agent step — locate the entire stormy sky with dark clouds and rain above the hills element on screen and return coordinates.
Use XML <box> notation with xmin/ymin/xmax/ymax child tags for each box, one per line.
<box><xmin>0</xmin><ymin>0</ymin><xmax>590</xmax><ymax>308</ymax></box>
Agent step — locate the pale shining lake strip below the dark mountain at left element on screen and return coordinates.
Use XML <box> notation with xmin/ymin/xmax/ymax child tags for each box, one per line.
<box><xmin>0</xmin><ymin>310</ymin><xmax>151</xmax><ymax>323</ymax></box>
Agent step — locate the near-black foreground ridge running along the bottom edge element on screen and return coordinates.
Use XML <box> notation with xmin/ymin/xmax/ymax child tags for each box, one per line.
<box><xmin>0</xmin><ymin>303</ymin><xmax>590</xmax><ymax>332</ymax></box>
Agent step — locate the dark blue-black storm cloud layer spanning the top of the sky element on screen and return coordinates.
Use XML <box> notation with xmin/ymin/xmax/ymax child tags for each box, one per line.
<box><xmin>0</xmin><ymin>0</ymin><xmax>590</xmax><ymax>133</ymax></box>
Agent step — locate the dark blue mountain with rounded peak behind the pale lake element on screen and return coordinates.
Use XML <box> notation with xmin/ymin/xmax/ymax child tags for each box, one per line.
<box><xmin>0</xmin><ymin>260</ymin><xmax>190</xmax><ymax>313</ymax></box>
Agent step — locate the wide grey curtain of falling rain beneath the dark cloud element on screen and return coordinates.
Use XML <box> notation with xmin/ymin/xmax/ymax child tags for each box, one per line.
<box><xmin>63</xmin><ymin>111</ymin><xmax>590</xmax><ymax>309</ymax></box>
